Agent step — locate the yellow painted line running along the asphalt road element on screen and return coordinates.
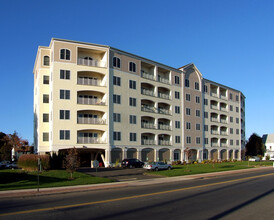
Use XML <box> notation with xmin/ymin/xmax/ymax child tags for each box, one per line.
<box><xmin>0</xmin><ymin>173</ymin><xmax>274</xmax><ymax>217</ymax></box>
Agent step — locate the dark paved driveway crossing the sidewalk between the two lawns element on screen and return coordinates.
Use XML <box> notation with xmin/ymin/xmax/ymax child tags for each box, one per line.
<box><xmin>78</xmin><ymin>168</ymin><xmax>160</xmax><ymax>182</ymax></box>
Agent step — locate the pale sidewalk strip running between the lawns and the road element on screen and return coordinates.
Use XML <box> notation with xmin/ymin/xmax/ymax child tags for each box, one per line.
<box><xmin>0</xmin><ymin>167</ymin><xmax>274</xmax><ymax>199</ymax></box>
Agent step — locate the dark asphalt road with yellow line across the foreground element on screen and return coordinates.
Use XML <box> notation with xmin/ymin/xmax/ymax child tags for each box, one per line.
<box><xmin>0</xmin><ymin>169</ymin><xmax>274</xmax><ymax>220</ymax></box>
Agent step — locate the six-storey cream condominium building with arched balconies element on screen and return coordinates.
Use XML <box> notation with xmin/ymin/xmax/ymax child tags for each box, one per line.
<box><xmin>33</xmin><ymin>39</ymin><xmax>245</xmax><ymax>167</ymax></box>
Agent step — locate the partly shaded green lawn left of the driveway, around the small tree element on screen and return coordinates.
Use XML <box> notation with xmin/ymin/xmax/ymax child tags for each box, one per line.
<box><xmin>0</xmin><ymin>169</ymin><xmax>112</xmax><ymax>190</ymax></box>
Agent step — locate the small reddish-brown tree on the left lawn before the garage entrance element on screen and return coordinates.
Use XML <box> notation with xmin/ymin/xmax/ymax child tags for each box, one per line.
<box><xmin>65</xmin><ymin>147</ymin><xmax>80</xmax><ymax>179</ymax></box>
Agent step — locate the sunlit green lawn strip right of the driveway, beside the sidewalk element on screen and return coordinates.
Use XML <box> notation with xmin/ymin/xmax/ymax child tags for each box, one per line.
<box><xmin>144</xmin><ymin>161</ymin><xmax>273</xmax><ymax>177</ymax></box>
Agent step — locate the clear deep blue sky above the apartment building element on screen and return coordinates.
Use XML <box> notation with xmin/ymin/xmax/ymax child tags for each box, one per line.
<box><xmin>0</xmin><ymin>0</ymin><xmax>274</xmax><ymax>143</ymax></box>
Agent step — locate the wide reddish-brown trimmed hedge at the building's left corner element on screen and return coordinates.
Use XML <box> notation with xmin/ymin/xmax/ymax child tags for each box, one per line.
<box><xmin>18</xmin><ymin>154</ymin><xmax>50</xmax><ymax>171</ymax></box>
